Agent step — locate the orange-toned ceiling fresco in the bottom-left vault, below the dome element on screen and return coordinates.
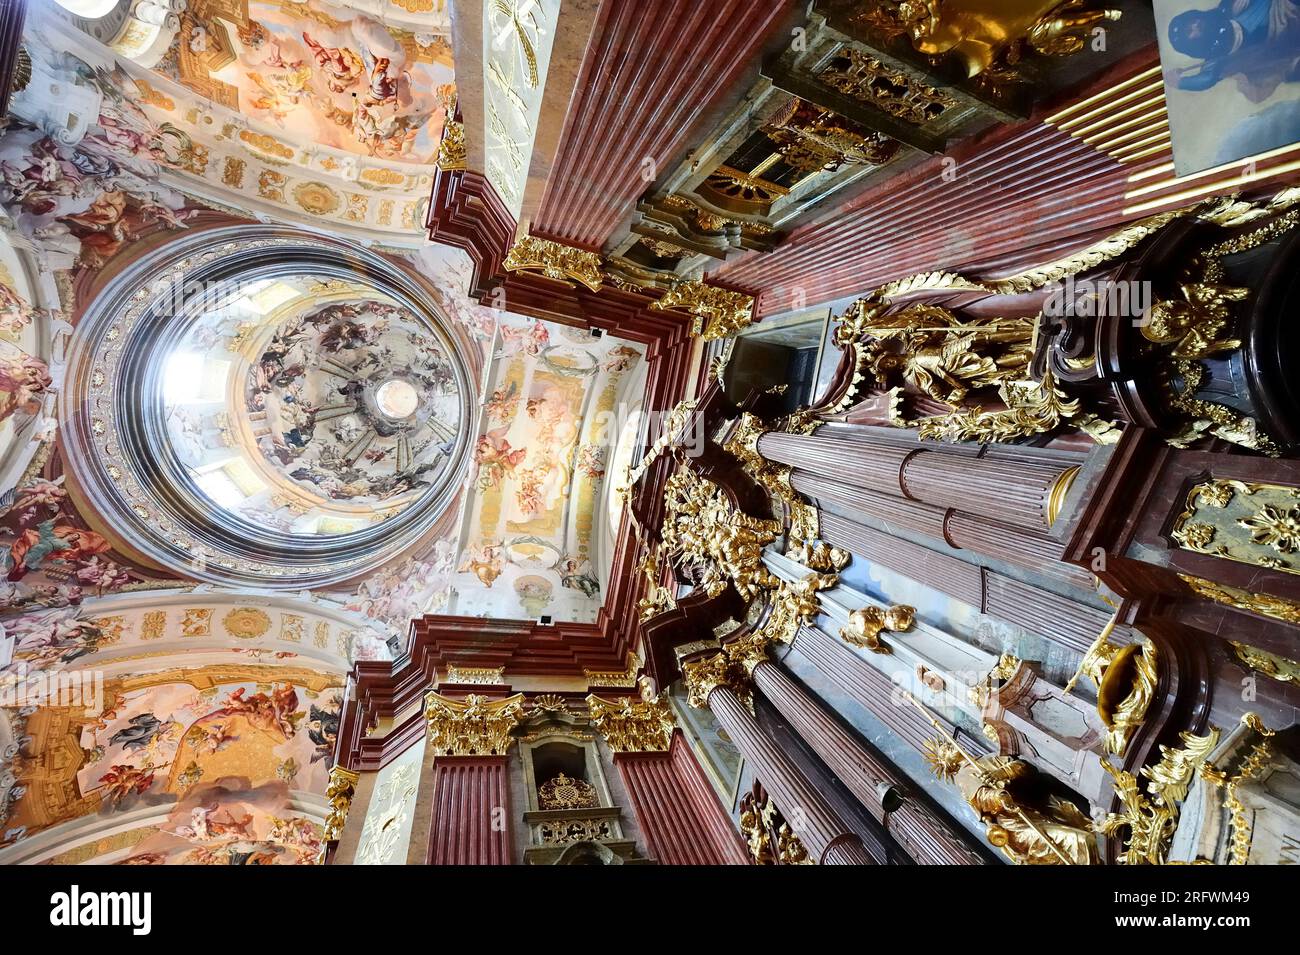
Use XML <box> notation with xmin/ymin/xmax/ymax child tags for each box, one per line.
<box><xmin>0</xmin><ymin>661</ymin><xmax>343</xmax><ymax>864</ymax></box>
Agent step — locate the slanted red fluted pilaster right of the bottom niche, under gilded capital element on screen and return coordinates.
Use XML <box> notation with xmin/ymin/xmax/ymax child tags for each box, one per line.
<box><xmin>614</xmin><ymin>732</ymin><xmax>750</xmax><ymax>865</ymax></box>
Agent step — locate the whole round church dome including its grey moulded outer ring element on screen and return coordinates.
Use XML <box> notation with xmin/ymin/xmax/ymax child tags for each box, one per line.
<box><xmin>64</xmin><ymin>226</ymin><xmax>473</xmax><ymax>587</ymax></box>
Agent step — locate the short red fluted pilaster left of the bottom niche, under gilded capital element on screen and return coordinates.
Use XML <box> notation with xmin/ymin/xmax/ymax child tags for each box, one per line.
<box><xmin>429</xmin><ymin>756</ymin><xmax>511</xmax><ymax>865</ymax></box>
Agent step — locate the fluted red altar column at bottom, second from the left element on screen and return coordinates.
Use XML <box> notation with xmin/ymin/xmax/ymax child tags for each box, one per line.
<box><xmin>753</xmin><ymin>661</ymin><xmax>984</xmax><ymax>865</ymax></box>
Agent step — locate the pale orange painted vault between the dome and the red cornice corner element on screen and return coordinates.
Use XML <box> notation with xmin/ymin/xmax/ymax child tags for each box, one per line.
<box><xmin>348</xmin><ymin>246</ymin><xmax>645</xmax><ymax>628</ymax></box>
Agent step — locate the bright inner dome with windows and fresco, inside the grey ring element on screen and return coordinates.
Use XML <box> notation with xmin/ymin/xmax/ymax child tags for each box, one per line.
<box><xmin>163</xmin><ymin>277</ymin><xmax>459</xmax><ymax>535</ymax></box>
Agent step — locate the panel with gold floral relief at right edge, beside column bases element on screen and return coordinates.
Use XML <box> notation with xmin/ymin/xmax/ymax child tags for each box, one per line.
<box><xmin>1170</xmin><ymin>479</ymin><xmax>1300</xmax><ymax>574</ymax></box>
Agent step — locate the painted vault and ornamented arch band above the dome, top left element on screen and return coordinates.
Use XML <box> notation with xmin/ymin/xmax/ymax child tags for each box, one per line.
<box><xmin>8</xmin><ymin>3</ymin><xmax>454</xmax><ymax>244</ymax></box>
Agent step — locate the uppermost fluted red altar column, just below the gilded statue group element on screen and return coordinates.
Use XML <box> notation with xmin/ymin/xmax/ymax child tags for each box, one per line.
<box><xmin>758</xmin><ymin>431</ymin><xmax>1073</xmax><ymax>530</ymax></box>
